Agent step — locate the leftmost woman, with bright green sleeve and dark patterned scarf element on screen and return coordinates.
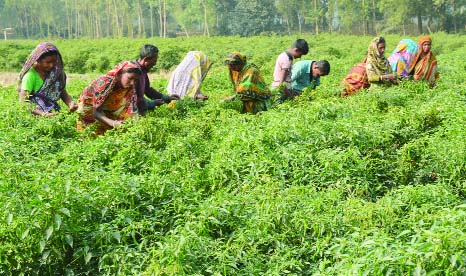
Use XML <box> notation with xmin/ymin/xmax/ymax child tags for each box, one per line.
<box><xmin>18</xmin><ymin>42</ymin><xmax>78</xmax><ymax>116</ymax></box>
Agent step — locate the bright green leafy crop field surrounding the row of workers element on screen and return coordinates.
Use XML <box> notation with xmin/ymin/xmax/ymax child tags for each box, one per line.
<box><xmin>0</xmin><ymin>33</ymin><xmax>466</xmax><ymax>275</ymax></box>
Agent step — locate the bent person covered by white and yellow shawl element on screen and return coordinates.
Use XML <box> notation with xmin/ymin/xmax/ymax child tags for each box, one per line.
<box><xmin>167</xmin><ymin>51</ymin><xmax>212</xmax><ymax>100</ymax></box>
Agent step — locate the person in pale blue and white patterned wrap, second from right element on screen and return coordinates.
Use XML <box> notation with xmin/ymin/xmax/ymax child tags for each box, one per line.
<box><xmin>388</xmin><ymin>38</ymin><xmax>419</xmax><ymax>78</ymax></box>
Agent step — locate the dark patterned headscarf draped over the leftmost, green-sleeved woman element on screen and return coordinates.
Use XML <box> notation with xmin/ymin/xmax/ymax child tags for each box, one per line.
<box><xmin>17</xmin><ymin>42</ymin><xmax>66</xmax><ymax>112</ymax></box>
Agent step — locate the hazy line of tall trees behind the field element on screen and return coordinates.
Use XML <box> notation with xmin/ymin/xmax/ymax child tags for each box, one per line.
<box><xmin>0</xmin><ymin>0</ymin><xmax>466</xmax><ymax>39</ymax></box>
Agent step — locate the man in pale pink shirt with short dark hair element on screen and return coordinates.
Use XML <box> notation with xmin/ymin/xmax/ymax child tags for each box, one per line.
<box><xmin>271</xmin><ymin>39</ymin><xmax>309</xmax><ymax>103</ymax></box>
